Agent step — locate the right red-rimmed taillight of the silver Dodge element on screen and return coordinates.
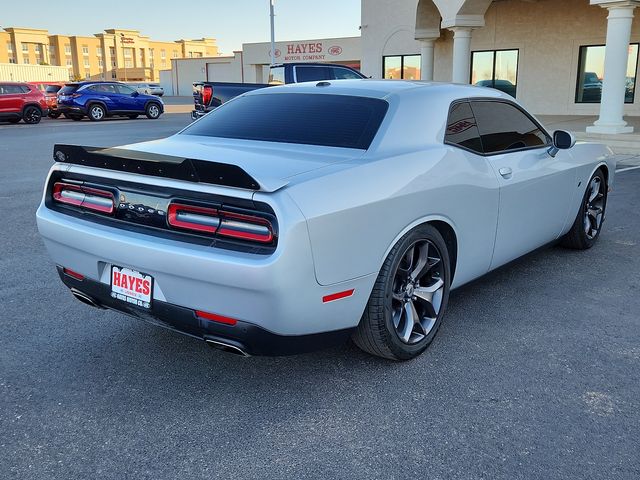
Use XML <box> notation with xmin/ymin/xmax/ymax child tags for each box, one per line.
<box><xmin>167</xmin><ymin>203</ymin><xmax>274</xmax><ymax>244</ymax></box>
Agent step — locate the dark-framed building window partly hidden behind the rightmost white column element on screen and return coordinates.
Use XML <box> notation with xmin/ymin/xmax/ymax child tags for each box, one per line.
<box><xmin>576</xmin><ymin>43</ymin><xmax>638</xmax><ymax>103</ymax></box>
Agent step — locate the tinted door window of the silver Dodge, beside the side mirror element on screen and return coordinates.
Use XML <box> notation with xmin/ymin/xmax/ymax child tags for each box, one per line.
<box><xmin>471</xmin><ymin>101</ymin><xmax>549</xmax><ymax>153</ymax></box>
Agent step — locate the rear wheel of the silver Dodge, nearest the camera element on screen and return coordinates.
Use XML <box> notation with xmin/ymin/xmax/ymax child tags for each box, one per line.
<box><xmin>352</xmin><ymin>225</ymin><xmax>451</xmax><ymax>360</ymax></box>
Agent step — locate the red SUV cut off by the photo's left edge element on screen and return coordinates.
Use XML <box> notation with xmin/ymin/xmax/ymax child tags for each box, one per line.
<box><xmin>0</xmin><ymin>82</ymin><xmax>49</xmax><ymax>124</ymax></box>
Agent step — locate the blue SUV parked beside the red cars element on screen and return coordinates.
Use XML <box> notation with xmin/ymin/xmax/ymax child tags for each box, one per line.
<box><xmin>56</xmin><ymin>82</ymin><xmax>164</xmax><ymax>122</ymax></box>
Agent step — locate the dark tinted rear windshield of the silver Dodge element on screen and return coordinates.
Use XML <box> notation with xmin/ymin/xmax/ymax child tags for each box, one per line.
<box><xmin>184</xmin><ymin>93</ymin><xmax>389</xmax><ymax>150</ymax></box>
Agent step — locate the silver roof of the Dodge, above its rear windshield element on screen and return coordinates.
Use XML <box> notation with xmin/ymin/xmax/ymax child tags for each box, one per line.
<box><xmin>247</xmin><ymin>79</ymin><xmax>513</xmax><ymax>100</ymax></box>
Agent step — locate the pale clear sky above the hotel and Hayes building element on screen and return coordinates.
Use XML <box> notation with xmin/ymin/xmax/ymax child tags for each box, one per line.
<box><xmin>0</xmin><ymin>0</ymin><xmax>360</xmax><ymax>54</ymax></box>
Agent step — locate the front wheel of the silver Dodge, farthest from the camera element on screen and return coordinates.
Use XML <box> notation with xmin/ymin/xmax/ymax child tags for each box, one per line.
<box><xmin>561</xmin><ymin>170</ymin><xmax>609</xmax><ymax>250</ymax></box>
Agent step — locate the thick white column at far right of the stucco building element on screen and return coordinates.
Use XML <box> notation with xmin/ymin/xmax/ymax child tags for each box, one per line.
<box><xmin>587</xmin><ymin>0</ymin><xmax>638</xmax><ymax>133</ymax></box>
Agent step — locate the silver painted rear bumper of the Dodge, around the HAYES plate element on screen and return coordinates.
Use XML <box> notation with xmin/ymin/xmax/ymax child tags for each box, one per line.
<box><xmin>37</xmin><ymin>195</ymin><xmax>376</xmax><ymax>342</ymax></box>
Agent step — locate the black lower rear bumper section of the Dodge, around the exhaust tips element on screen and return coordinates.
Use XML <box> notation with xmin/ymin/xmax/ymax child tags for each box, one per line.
<box><xmin>57</xmin><ymin>266</ymin><xmax>353</xmax><ymax>356</ymax></box>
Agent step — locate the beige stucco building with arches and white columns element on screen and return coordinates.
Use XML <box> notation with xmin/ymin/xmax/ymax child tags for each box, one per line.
<box><xmin>361</xmin><ymin>0</ymin><xmax>640</xmax><ymax>133</ymax></box>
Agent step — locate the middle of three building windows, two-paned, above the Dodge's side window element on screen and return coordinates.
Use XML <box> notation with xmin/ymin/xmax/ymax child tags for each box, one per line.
<box><xmin>471</xmin><ymin>50</ymin><xmax>519</xmax><ymax>98</ymax></box>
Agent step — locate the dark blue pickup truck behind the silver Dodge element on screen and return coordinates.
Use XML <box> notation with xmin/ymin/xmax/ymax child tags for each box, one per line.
<box><xmin>191</xmin><ymin>63</ymin><xmax>366</xmax><ymax>120</ymax></box>
